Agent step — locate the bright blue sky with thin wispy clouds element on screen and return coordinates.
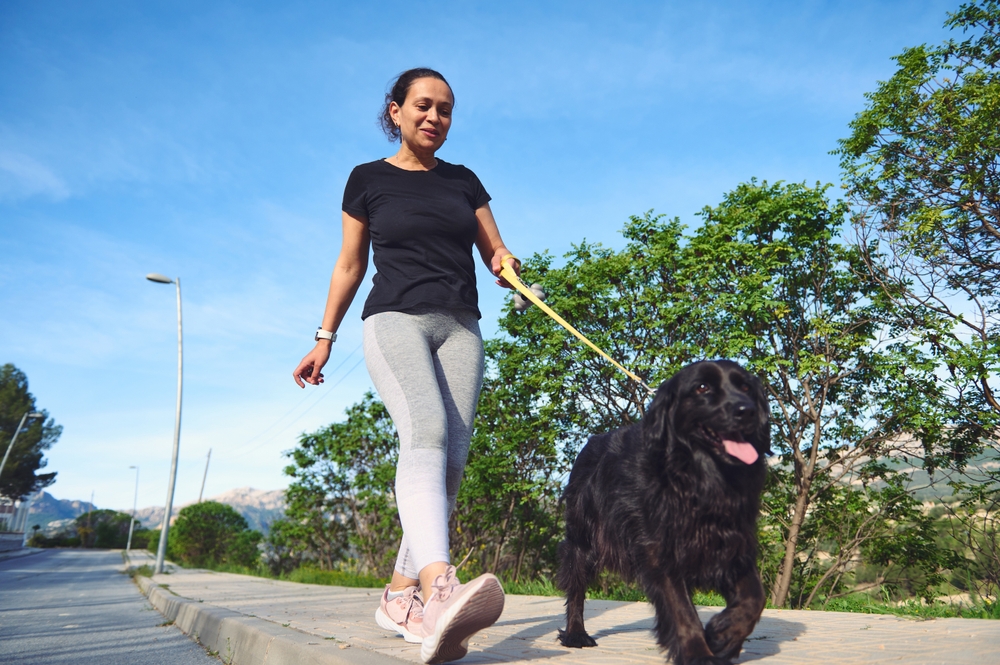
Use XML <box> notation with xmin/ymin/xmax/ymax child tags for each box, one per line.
<box><xmin>0</xmin><ymin>0</ymin><xmax>958</xmax><ymax>508</ymax></box>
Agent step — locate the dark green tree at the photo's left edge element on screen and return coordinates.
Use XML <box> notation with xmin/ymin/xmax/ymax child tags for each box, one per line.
<box><xmin>0</xmin><ymin>363</ymin><xmax>62</xmax><ymax>500</ymax></box>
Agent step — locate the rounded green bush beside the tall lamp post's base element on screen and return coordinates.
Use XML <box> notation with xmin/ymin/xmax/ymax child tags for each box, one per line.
<box><xmin>167</xmin><ymin>501</ymin><xmax>262</xmax><ymax>567</ymax></box>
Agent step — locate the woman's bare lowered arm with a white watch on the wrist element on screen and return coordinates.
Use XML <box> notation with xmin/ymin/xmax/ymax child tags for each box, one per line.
<box><xmin>292</xmin><ymin>212</ymin><xmax>371</xmax><ymax>388</ymax></box>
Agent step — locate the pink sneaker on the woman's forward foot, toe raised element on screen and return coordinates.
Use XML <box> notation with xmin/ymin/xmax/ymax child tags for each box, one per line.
<box><xmin>420</xmin><ymin>566</ymin><xmax>503</xmax><ymax>663</ymax></box>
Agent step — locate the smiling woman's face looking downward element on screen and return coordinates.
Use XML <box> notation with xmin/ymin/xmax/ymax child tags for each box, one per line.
<box><xmin>389</xmin><ymin>78</ymin><xmax>455</xmax><ymax>154</ymax></box>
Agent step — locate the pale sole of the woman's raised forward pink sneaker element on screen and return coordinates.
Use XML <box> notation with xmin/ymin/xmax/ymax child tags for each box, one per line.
<box><xmin>420</xmin><ymin>573</ymin><xmax>504</xmax><ymax>665</ymax></box>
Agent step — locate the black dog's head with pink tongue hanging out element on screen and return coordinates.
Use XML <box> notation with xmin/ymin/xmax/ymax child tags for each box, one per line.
<box><xmin>644</xmin><ymin>360</ymin><xmax>771</xmax><ymax>466</ymax></box>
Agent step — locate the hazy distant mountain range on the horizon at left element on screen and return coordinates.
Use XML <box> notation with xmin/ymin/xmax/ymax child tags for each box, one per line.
<box><xmin>27</xmin><ymin>487</ymin><xmax>285</xmax><ymax>534</ymax></box>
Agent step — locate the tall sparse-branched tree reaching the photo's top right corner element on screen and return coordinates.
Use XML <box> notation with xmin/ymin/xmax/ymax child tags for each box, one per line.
<box><xmin>837</xmin><ymin>0</ymin><xmax>1000</xmax><ymax>422</ymax></box>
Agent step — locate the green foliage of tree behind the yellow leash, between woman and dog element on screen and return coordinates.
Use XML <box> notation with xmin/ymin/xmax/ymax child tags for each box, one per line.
<box><xmin>491</xmin><ymin>213</ymin><xmax>697</xmax><ymax>444</ymax></box>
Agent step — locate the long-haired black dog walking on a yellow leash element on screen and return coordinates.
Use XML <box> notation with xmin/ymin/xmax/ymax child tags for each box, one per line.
<box><xmin>559</xmin><ymin>360</ymin><xmax>771</xmax><ymax>665</ymax></box>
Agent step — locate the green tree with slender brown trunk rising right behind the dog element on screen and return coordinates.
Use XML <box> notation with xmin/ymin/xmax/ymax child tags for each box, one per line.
<box><xmin>686</xmin><ymin>181</ymin><xmax>983</xmax><ymax>607</ymax></box>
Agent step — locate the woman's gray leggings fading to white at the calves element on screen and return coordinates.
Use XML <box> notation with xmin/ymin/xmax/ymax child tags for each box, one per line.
<box><xmin>364</xmin><ymin>309</ymin><xmax>483</xmax><ymax>579</ymax></box>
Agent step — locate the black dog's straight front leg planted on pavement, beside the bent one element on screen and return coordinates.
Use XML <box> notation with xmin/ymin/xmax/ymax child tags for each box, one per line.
<box><xmin>643</xmin><ymin>570</ymin><xmax>729</xmax><ymax>665</ymax></box>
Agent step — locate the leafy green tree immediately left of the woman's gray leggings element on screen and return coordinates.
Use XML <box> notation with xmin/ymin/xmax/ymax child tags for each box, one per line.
<box><xmin>279</xmin><ymin>393</ymin><xmax>402</xmax><ymax>576</ymax></box>
